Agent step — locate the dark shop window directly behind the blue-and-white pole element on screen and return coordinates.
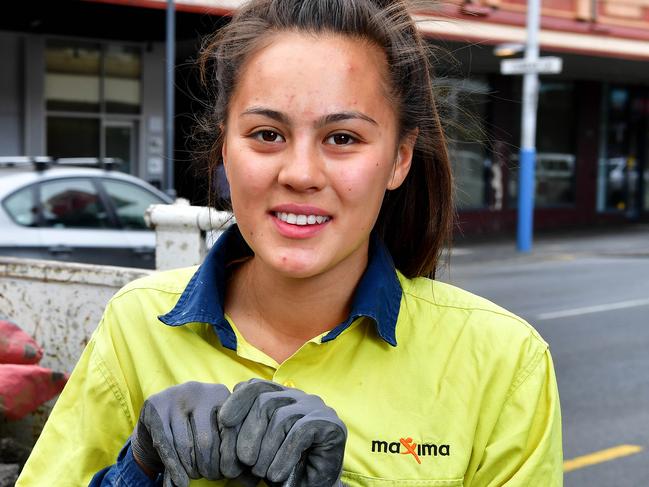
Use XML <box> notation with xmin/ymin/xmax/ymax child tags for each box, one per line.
<box><xmin>508</xmin><ymin>81</ymin><xmax>577</xmax><ymax>208</ymax></box>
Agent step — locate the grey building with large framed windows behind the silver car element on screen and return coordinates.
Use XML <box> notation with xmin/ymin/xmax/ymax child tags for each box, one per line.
<box><xmin>0</xmin><ymin>0</ymin><xmax>218</xmax><ymax>191</ymax></box>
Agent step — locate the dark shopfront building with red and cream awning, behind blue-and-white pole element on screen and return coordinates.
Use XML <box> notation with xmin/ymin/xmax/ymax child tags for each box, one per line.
<box><xmin>422</xmin><ymin>0</ymin><xmax>649</xmax><ymax>234</ymax></box>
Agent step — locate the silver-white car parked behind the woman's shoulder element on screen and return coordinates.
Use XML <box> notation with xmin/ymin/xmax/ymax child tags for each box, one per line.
<box><xmin>0</xmin><ymin>157</ymin><xmax>173</xmax><ymax>268</ymax></box>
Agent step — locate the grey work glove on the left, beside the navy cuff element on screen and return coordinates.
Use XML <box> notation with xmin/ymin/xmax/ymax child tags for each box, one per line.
<box><xmin>131</xmin><ymin>382</ymin><xmax>230</xmax><ymax>487</ymax></box>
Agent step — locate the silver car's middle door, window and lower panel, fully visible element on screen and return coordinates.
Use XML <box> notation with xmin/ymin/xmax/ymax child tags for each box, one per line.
<box><xmin>38</xmin><ymin>177</ymin><xmax>131</xmax><ymax>266</ymax></box>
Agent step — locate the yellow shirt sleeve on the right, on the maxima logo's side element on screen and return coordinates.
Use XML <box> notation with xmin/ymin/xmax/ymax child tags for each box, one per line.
<box><xmin>465</xmin><ymin>349</ymin><xmax>563</xmax><ymax>487</ymax></box>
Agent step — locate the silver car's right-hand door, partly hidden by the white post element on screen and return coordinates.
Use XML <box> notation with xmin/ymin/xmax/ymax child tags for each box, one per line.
<box><xmin>100</xmin><ymin>178</ymin><xmax>169</xmax><ymax>269</ymax></box>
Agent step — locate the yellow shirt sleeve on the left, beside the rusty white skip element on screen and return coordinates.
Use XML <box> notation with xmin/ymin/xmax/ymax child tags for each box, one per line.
<box><xmin>16</xmin><ymin>305</ymin><xmax>137</xmax><ymax>487</ymax></box>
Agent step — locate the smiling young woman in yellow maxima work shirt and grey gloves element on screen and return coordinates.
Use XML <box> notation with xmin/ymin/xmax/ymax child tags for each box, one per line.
<box><xmin>18</xmin><ymin>0</ymin><xmax>562</xmax><ymax>487</ymax></box>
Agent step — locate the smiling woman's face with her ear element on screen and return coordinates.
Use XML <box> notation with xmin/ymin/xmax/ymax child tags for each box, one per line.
<box><xmin>223</xmin><ymin>33</ymin><xmax>414</xmax><ymax>278</ymax></box>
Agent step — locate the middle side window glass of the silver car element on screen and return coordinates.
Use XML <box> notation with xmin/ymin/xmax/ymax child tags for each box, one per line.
<box><xmin>40</xmin><ymin>178</ymin><xmax>113</xmax><ymax>228</ymax></box>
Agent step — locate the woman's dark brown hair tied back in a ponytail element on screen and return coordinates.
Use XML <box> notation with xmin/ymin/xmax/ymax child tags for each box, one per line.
<box><xmin>196</xmin><ymin>0</ymin><xmax>454</xmax><ymax>277</ymax></box>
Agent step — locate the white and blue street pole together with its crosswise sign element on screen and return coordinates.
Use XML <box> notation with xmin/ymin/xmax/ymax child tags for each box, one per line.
<box><xmin>500</xmin><ymin>0</ymin><xmax>562</xmax><ymax>252</ymax></box>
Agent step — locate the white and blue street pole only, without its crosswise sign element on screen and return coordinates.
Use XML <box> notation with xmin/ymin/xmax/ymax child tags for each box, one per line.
<box><xmin>517</xmin><ymin>0</ymin><xmax>541</xmax><ymax>252</ymax></box>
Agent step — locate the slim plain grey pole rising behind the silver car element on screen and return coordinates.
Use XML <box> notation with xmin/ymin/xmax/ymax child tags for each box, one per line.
<box><xmin>164</xmin><ymin>0</ymin><xmax>176</xmax><ymax>198</ymax></box>
